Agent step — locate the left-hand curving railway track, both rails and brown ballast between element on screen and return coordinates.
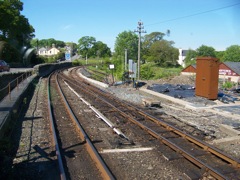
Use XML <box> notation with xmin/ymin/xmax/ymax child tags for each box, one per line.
<box><xmin>48</xmin><ymin>72</ymin><xmax>115</xmax><ymax>179</ymax></box>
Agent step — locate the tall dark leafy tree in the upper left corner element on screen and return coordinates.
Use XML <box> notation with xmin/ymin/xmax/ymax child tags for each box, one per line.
<box><xmin>0</xmin><ymin>0</ymin><xmax>35</xmax><ymax>62</ymax></box>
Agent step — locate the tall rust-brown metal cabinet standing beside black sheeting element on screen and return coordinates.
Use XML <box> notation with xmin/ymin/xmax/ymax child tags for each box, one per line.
<box><xmin>195</xmin><ymin>57</ymin><xmax>219</xmax><ymax>100</ymax></box>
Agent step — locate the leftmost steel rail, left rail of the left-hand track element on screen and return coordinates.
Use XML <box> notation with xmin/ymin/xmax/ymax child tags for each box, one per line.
<box><xmin>47</xmin><ymin>73</ymin><xmax>67</xmax><ymax>180</ymax></box>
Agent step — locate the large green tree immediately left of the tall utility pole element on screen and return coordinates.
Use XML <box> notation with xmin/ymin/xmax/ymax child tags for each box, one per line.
<box><xmin>114</xmin><ymin>31</ymin><xmax>138</xmax><ymax>60</ymax></box>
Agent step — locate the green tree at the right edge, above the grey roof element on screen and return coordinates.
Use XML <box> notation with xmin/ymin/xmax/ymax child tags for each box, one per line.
<box><xmin>222</xmin><ymin>45</ymin><xmax>240</xmax><ymax>62</ymax></box>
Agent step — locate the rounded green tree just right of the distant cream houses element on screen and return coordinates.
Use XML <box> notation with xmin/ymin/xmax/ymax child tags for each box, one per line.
<box><xmin>78</xmin><ymin>36</ymin><xmax>96</xmax><ymax>58</ymax></box>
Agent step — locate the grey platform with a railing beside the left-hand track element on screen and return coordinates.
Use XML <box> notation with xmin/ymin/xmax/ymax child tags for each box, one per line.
<box><xmin>0</xmin><ymin>75</ymin><xmax>36</xmax><ymax>139</ymax></box>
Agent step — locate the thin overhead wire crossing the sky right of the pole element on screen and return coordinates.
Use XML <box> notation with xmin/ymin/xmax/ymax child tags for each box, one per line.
<box><xmin>145</xmin><ymin>3</ymin><xmax>240</xmax><ymax>26</ymax></box>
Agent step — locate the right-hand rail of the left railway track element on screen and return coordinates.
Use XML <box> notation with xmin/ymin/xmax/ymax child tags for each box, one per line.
<box><xmin>56</xmin><ymin>71</ymin><xmax>115</xmax><ymax>179</ymax></box>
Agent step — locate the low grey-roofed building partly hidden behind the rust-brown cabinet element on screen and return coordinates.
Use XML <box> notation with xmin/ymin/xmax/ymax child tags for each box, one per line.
<box><xmin>181</xmin><ymin>62</ymin><xmax>240</xmax><ymax>83</ymax></box>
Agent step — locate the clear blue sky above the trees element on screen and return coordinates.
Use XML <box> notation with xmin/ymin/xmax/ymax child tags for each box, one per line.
<box><xmin>22</xmin><ymin>0</ymin><xmax>240</xmax><ymax>50</ymax></box>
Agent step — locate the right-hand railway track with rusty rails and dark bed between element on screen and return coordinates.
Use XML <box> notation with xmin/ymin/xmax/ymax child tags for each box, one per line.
<box><xmin>58</xmin><ymin>69</ymin><xmax>240</xmax><ymax>179</ymax></box>
